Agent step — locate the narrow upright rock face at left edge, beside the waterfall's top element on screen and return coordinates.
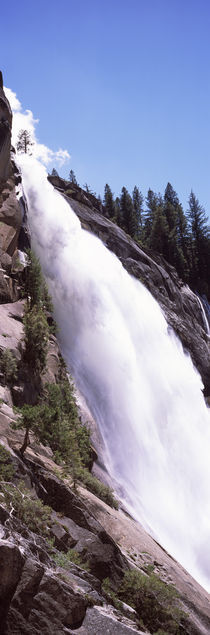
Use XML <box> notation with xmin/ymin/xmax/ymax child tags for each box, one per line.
<box><xmin>0</xmin><ymin>71</ymin><xmax>12</xmax><ymax>184</ymax></box>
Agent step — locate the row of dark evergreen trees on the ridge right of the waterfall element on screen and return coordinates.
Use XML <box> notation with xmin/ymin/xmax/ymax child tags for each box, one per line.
<box><xmin>103</xmin><ymin>183</ymin><xmax>210</xmax><ymax>299</ymax></box>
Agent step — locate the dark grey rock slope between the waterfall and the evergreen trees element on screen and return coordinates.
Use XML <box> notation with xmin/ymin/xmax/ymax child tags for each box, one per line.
<box><xmin>49</xmin><ymin>176</ymin><xmax>210</xmax><ymax>396</ymax></box>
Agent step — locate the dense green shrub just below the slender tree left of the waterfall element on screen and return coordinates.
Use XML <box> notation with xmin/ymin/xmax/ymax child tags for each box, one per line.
<box><xmin>23</xmin><ymin>305</ymin><xmax>49</xmax><ymax>376</ymax></box>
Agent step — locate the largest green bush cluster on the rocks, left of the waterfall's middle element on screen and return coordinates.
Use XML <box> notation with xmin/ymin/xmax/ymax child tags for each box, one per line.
<box><xmin>15</xmin><ymin>380</ymin><xmax>91</xmax><ymax>485</ymax></box>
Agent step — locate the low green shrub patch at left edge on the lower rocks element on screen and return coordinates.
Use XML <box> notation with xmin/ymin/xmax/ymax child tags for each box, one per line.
<box><xmin>1</xmin><ymin>481</ymin><xmax>51</xmax><ymax>536</ymax></box>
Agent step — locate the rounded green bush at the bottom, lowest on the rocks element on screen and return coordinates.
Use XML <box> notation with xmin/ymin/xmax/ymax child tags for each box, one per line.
<box><xmin>118</xmin><ymin>569</ymin><xmax>183</xmax><ymax>635</ymax></box>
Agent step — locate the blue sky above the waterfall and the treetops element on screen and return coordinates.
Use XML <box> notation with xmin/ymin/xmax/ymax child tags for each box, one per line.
<box><xmin>0</xmin><ymin>0</ymin><xmax>210</xmax><ymax>220</ymax></box>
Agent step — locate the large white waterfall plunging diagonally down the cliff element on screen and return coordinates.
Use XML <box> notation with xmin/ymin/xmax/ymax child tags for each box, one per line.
<box><xmin>17</xmin><ymin>157</ymin><xmax>210</xmax><ymax>589</ymax></box>
